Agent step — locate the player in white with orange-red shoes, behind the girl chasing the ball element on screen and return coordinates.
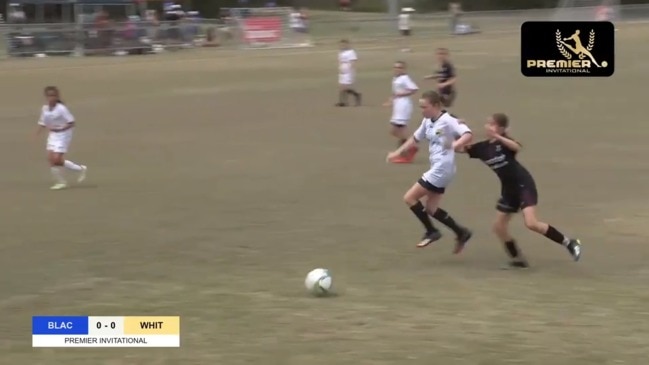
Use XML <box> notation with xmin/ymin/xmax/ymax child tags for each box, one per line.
<box><xmin>385</xmin><ymin>61</ymin><xmax>419</xmax><ymax>163</ymax></box>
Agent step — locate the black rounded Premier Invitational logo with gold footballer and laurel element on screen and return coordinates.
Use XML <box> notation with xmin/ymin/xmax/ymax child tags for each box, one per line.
<box><xmin>521</xmin><ymin>22</ymin><xmax>615</xmax><ymax>77</ymax></box>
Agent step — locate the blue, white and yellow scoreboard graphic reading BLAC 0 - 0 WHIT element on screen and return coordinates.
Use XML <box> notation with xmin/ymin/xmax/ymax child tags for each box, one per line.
<box><xmin>32</xmin><ymin>316</ymin><xmax>180</xmax><ymax>347</ymax></box>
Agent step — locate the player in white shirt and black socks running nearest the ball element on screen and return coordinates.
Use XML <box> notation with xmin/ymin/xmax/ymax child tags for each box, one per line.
<box><xmin>387</xmin><ymin>91</ymin><xmax>473</xmax><ymax>253</ymax></box>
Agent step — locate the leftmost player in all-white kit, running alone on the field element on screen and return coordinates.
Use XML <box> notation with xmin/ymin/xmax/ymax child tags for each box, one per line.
<box><xmin>36</xmin><ymin>86</ymin><xmax>88</xmax><ymax>190</ymax></box>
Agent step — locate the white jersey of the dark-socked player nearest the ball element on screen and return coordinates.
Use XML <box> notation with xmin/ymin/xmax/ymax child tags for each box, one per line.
<box><xmin>413</xmin><ymin>112</ymin><xmax>471</xmax><ymax>188</ymax></box>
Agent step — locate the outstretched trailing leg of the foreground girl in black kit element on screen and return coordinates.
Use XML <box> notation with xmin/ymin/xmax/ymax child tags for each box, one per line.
<box><xmin>519</xmin><ymin>184</ymin><xmax>581</xmax><ymax>261</ymax></box>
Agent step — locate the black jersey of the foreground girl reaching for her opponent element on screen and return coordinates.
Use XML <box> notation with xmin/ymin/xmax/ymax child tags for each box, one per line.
<box><xmin>467</xmin><ymin>141</ymin><xmax>534</xmax><ymax>186</ymax></box>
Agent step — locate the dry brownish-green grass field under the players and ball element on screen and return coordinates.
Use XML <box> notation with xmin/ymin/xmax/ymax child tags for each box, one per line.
<box><xmin>0</xmin><ymin>22</ymin><xmax>649</xmax><ymax>365</ymax></box>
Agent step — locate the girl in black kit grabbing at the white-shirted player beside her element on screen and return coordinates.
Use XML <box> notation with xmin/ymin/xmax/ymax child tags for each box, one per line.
<box><xmin>458</xmin><ymin>113</ymin><xmax>581</xmax><ymax>268</ymax></box>
